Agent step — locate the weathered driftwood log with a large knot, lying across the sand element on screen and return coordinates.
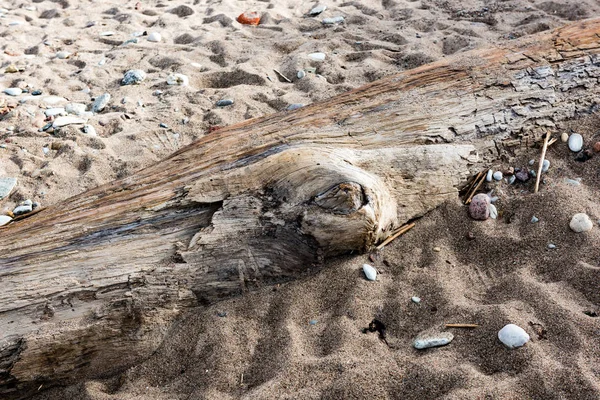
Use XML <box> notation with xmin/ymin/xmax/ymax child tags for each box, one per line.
<box><xmin>0</xmin><ymin>20</ymin><xmax>600</xmax><ymax>399</ymax></box>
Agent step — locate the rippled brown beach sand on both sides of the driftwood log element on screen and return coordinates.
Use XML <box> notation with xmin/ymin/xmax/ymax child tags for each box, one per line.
<box><xmin>0</xmin><ymin>0</ymin><xmax>600</xmax><ymax>400</ymax></box>
